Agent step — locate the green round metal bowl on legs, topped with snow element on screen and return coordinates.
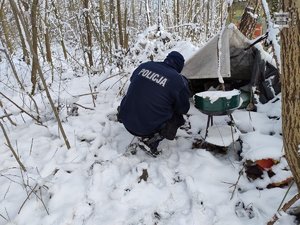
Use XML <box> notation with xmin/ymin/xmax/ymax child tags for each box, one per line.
<box><xmin>194</xmin><ymin>90</ymin><xmax>240</xmax><ymax>115</ymax></box>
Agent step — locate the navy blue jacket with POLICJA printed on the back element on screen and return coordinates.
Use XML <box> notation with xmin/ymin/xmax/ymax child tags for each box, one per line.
<box><xmin>119</xmin><ymin>61</ymin><xmax>190</xmax><ymax>136</ymax></box>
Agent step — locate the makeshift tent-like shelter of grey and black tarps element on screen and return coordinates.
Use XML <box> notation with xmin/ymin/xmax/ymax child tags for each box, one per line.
<box><xmin>182</xmin><ymin>24</ymin><xmax>280</xmax><ymax>103</ymax></box>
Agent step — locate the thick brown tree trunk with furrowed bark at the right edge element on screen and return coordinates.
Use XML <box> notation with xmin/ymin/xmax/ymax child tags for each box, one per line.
<box><xmin>281</xmin><ymin>0</ymin><xmax>300</xmax><ymax>191</ymax></box>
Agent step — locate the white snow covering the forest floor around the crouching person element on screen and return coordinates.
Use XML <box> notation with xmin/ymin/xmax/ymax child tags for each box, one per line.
<box><xmin>0</xmin><ymin>31</ymin><xmax>297</xmax><ymax>225</ymax></box>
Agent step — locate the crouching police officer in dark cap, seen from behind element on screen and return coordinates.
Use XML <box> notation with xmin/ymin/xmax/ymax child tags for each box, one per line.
<box><xmin>118</xmin><ymin>51</ymin><xmax>190</xmax><ymax>155</ymax></box>
